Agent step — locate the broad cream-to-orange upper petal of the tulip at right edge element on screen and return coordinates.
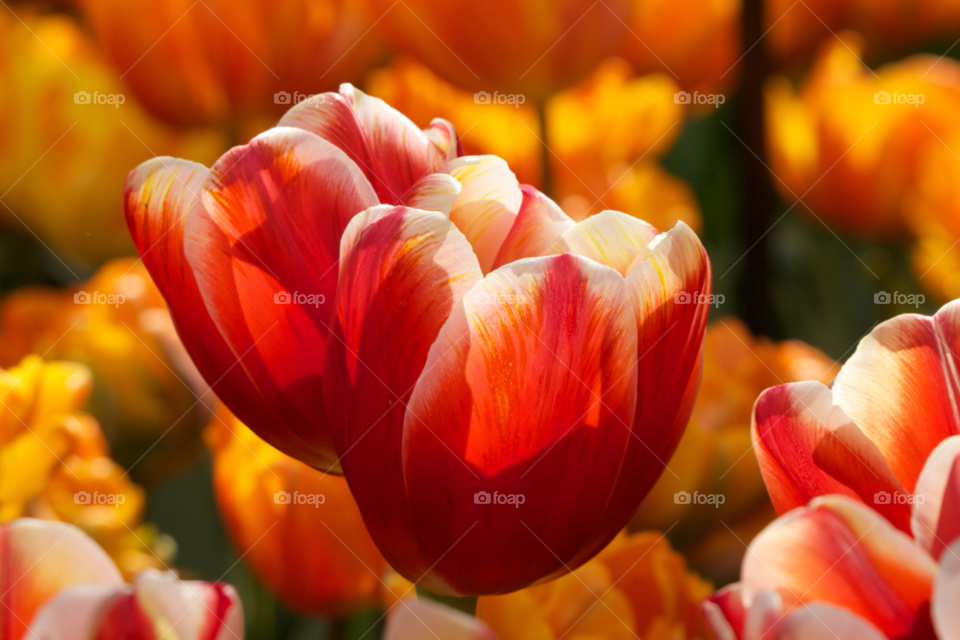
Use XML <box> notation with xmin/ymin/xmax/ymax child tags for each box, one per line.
<box><xmin>833</xmin><ymin>301</ymin><xmax>960</xmax><ymax>492</ymax></box>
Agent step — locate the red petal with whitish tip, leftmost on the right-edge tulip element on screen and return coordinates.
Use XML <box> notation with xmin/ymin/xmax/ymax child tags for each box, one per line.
<box><xmin>753</xmin><ymin>382</ymin><xmax>910</xmax><ymax>531</ymax></box>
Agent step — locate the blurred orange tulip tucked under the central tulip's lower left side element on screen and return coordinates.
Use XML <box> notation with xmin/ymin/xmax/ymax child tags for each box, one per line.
<box><xmin>205</xmin><ymin>409</ymin><xmax>386</xmax><ymax>615</ymax></box>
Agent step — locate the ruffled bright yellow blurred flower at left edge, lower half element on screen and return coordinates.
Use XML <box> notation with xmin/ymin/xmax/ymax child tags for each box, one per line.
<box><xmin>0</xmin><ymin>356</ymin><xmax>174</xmax><ymax>577</ymax></box>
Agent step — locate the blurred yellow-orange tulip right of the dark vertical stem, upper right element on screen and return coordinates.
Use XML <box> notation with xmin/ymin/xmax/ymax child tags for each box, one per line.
<box><xmin>766</xmin><ymin>33</ymin><xmax>960</xmax><ymax>235</ymax></box>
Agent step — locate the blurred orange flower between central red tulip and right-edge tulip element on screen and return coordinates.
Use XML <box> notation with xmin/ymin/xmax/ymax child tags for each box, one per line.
<box><xmin>629</xmin><ymin>317</ymin><xmax>839</xmax><ymax>582</ymax></box>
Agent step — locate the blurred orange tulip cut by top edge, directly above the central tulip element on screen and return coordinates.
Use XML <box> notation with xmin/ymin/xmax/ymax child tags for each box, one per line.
<box><xmin>356</xmin><ymin>0</ymin><xmax>630</xmax><ymax>102</ymax></box>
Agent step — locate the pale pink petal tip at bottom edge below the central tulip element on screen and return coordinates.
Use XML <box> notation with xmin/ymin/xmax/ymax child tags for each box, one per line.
<box><xmin>383</xmin><ymin>598</ymin><xmax>497</xmax><ymax>640</ymax></box>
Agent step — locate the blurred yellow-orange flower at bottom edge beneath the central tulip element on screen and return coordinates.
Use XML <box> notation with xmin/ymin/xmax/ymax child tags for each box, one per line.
<box><xmin>384</xmin><ymin>532</ymin><xmax>712</xmax><ymax>640</ymax></box>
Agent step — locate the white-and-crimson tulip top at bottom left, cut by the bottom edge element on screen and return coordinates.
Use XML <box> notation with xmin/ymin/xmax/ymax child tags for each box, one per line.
<box><xmin>28</xmin><ymin>569</ymin><xmax>243</xmax><ymax>640</ymax></box>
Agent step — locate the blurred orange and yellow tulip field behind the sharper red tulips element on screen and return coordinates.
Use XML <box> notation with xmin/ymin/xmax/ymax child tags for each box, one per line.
<box><xmin>0</xmin><ymin>0</ymin><xmax>960</xmax><ymax>639</ymax></box>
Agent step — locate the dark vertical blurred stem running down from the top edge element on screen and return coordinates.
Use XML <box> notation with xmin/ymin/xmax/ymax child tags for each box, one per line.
<box><xmin>739</xmin><ymin>0</ymin><xmax>775</xmax><ymax>336</ymax></box>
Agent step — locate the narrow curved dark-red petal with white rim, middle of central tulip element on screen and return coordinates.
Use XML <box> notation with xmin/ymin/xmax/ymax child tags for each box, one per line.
<box><xmin>324</xmin><ymin>206</ymin><xmax>482</xmax><ymax>581</ymax></box>
